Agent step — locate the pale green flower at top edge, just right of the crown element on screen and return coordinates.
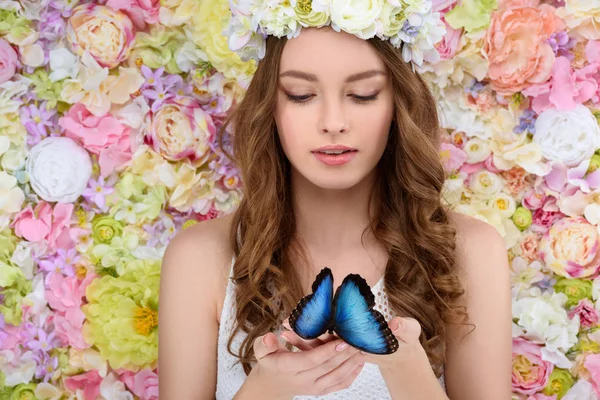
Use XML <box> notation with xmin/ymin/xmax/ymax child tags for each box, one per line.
<box><xmin>444</xmin><ymin>0</ymin><xmax>498</xmax><ymax>32</ymax></box>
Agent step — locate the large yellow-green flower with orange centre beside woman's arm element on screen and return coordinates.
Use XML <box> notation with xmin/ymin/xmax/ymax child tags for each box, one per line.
<box><xmin>82</xmin><ymin>260</ymin><xmax>160</xmax><ymax>371</ymax></box>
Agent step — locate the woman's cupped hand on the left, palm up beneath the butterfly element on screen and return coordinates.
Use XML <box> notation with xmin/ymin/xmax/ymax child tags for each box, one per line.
<box><xmin>240</xmin><ymin>333</ymin><xmax>364</xmax><ymax>400</ymax></box>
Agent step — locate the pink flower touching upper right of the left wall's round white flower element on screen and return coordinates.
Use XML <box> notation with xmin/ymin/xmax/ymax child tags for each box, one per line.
<box><xmin>58</xmin><ymin>103</ymin><xmax>132</xmax><ymax>176</ymax></box>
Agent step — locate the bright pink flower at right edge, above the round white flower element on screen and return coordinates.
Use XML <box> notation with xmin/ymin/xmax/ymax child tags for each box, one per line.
<box><xmin>522</xmin><ymin>57</ymin><xmax>600</xmax><ymax>114</ymax></box>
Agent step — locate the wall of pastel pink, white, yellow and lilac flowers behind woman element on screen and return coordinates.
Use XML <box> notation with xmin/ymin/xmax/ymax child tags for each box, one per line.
<box><xmin>0</xmin><ymin>0</ymin><xmax>600</xmax><ymax>400</ymax></box>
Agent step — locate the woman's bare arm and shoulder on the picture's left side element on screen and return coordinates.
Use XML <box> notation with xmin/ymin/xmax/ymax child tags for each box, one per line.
<box><xmin>158</xmin><ymin>212</ymin><xmax>233</xmax><ymax>399</ymax></box>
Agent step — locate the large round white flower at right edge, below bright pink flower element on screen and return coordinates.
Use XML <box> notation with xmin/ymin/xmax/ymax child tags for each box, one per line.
<box><xmin>533</xmin><ymin>104</ymin><xmax>600</xmax><ymax>167</ymax></box>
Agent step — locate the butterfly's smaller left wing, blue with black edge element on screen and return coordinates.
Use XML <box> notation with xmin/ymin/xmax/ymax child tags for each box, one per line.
<box><xmin>290</xmin><ymin>268</ymin><xmax>333</xmax><ymax>339</ymax></box>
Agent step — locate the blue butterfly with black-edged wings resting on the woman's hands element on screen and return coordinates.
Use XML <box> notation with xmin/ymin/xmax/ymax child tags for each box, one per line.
<box><xmin>289</xmin><ymin>267</ymin><xmax>398</xmax><ymax>354</ymax></box>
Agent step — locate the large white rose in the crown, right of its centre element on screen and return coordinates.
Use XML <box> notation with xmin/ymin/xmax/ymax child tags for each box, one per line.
<box><xmin>330</xmin><ymin>0</ymin><xmax>383</xmax><ymax>39</ymax></box>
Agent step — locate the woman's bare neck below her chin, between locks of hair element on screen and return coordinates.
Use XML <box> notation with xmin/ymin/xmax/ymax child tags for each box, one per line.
<box><xmin>291</xmin><ymin>166</ymin><xmax>376</xmax><ymax>256</ymax></box>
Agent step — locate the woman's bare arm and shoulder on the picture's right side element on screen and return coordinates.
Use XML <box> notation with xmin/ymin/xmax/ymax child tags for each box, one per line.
<box><xmin>446</xmin><ymin>212</ymin><xmax>512</xmax><ymax>400</ymax></box>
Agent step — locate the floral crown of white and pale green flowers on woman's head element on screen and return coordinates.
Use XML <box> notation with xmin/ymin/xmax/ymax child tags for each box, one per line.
<box><xmin>223</xmin><ymin>0</ymin><xmax>446</xmax><ymax>69</ymax></box>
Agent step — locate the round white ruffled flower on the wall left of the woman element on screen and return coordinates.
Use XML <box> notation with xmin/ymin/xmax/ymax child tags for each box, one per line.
<box><xmin>25</xmin><ymin>137</ymin><xmax>92</xmax><ymax>203</ymax></box>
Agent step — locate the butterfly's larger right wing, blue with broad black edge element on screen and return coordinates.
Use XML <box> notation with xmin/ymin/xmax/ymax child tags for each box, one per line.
<box><xmin>333</xmin><ymin>274</ymin><xmax>398</xmax><ymax>354</ymax></box>
